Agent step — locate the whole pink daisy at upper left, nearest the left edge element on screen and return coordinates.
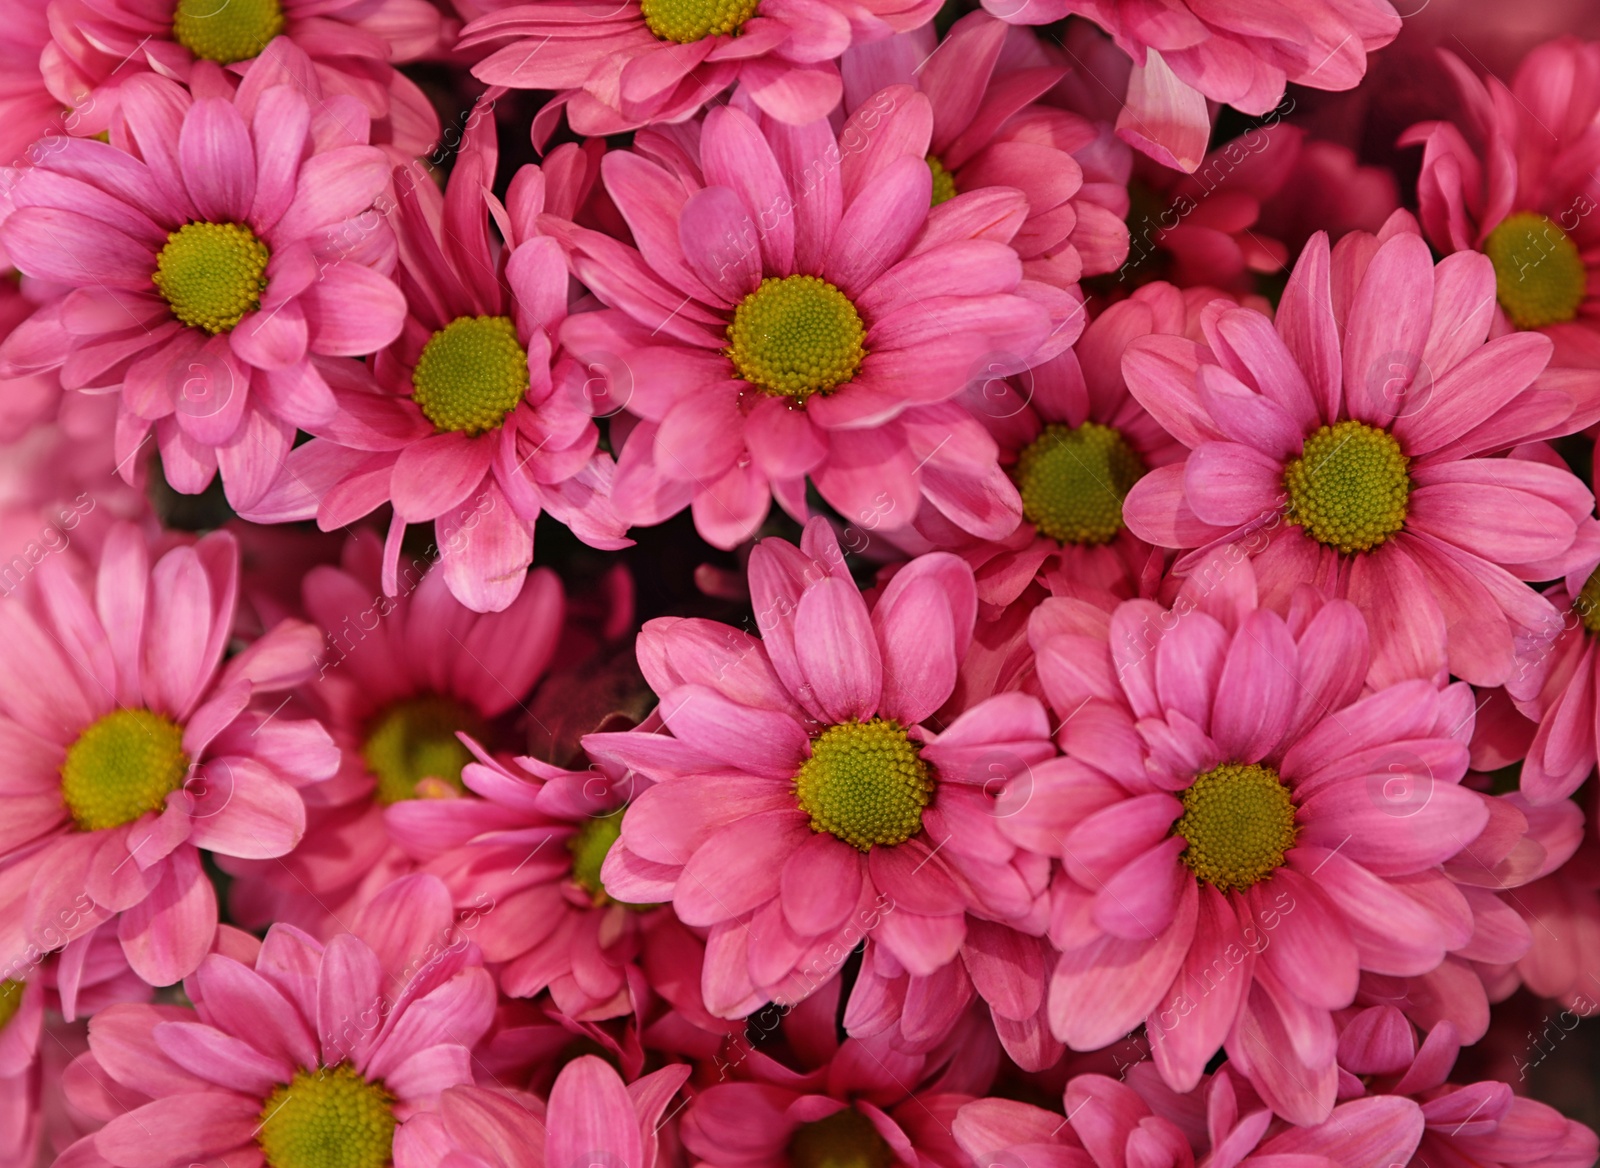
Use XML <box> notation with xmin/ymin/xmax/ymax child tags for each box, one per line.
<box><xmin>0</xmin><ymin>53</ymin><xmax>405</xmax><ymax>510</ymax></box>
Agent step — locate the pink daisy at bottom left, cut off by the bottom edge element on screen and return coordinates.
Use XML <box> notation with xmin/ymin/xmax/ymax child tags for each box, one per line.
<box><xmin>62</xmin><ymin>877</ymin><xmax>494</xmax><ymax>1168</ymax></box>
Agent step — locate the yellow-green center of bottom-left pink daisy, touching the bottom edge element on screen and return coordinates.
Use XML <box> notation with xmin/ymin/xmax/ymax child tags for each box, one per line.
<box><xmin>256</xmin><ymin>1062</ymin><xmax>395</xmax><ymax>1168</ymax></box>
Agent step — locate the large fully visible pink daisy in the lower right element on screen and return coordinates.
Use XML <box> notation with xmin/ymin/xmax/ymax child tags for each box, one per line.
<box><xmin>1017</xmin><ymin>555</ymin><xmax>1490</xmax><ymax>1123</ymax></box>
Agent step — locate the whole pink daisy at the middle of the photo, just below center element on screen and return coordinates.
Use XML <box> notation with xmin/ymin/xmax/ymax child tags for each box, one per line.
<box><xmin>584</xmin><ymin>520</ymin><xmax>1053</xmax><ymax>1018</ymax></box>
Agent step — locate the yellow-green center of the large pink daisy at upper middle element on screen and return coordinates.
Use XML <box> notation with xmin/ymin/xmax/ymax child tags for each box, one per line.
<box><xmin>728</xmin><ymin>275</ymin><xmax>867</xmax><ymax>402</ymax></box>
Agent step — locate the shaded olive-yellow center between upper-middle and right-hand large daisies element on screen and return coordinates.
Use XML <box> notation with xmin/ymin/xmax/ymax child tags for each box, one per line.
<box><xmin>1011</xmin><ymin>422</ymin><xmax>1144</xmax><ymax>544</ymax></box>
